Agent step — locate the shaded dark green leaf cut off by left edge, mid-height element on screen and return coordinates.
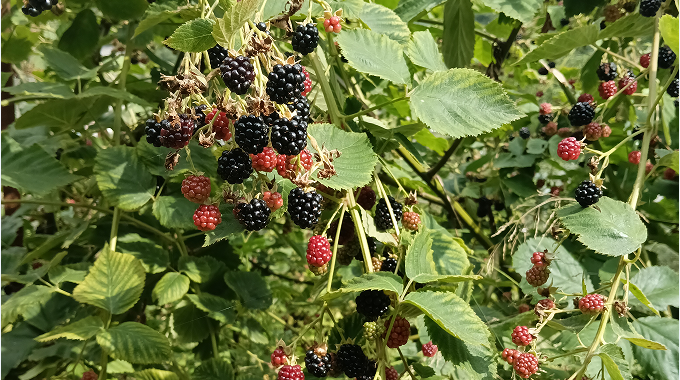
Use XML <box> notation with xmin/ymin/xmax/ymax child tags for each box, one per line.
<box><xmin>0</xmin><ymin>133</ymin><xmax>80</xmax><ymax>195</ymax></box>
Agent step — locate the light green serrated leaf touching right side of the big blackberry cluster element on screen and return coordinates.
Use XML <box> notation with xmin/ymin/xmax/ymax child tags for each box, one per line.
<box><xmin>307</xmin><ymin>124</ymin><xmax>378</xmax><ymax>190</ymax></box>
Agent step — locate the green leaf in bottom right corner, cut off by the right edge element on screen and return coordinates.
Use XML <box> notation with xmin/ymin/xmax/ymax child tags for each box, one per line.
<box><xmin>633</xmin><ymin>317</ymin><xmax>680</xmax><ymax>380</ymax></box>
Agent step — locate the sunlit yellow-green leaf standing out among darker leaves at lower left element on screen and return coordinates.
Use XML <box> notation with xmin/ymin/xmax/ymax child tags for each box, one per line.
<box><xmin>73</xmin><ymin>248</ymin><xmax>146</xmax><ymax>314</ymax></box>
